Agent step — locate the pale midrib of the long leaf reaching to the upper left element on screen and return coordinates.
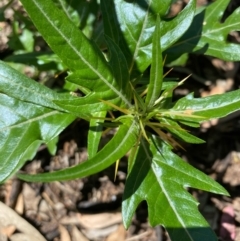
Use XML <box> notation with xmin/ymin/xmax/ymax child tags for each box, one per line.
<box><xmin>33</xmin><ymin>0</ymin><xmax>132</xmax><ymax>107</ymax></box>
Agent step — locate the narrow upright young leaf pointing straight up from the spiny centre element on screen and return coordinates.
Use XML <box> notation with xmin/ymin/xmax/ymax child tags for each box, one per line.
<box><xmin>145</xmin><ymin>15</ymin><xmax>163</xmax><ymax>108</ymax></box>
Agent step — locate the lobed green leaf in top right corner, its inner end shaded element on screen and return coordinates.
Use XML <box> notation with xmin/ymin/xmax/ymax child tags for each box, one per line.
<box><xmin>166</xmin><ymin>0</ymin><xmax>240</xmax><ymax>61</ymax></box>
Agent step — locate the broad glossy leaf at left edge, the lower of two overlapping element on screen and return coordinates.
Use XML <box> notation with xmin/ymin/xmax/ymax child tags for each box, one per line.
<box><xmin>0</xmin><ymin>94</ymin><xmax>76</xmax><ymax>182</ymax></box>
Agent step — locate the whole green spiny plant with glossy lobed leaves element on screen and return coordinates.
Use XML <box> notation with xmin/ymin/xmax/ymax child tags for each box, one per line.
<box><xmin>0</xmin><ymin>0</ymin><xmax>240</xmax><ymax>241</ymax></box>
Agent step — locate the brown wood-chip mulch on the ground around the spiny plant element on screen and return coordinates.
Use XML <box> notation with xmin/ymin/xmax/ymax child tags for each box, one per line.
<box><xmin>0</xmin><ymin>0</ymin><xmax>240</xmax><ymax>241</ymax></box>
